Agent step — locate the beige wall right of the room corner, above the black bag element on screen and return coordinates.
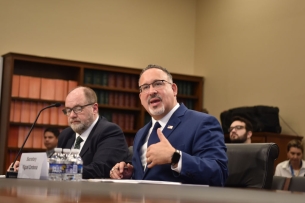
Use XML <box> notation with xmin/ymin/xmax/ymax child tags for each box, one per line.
<box><xmin>195</xmin><ymin>0</ymin><xmax>305</xmax><ymax>138</ymax></box>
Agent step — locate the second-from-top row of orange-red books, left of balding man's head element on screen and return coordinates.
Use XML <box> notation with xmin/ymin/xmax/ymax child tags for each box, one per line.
<box><xmin>10</xmin><ymin>100</ymin><xmax>68</xmax><ymax>126</ymax></box>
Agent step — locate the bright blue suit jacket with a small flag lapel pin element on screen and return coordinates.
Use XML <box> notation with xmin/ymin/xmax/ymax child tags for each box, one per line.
<box><xmin>132</xmin><ymin>104</ymin><xmax>228</xmax><ymax>186</ymax></box>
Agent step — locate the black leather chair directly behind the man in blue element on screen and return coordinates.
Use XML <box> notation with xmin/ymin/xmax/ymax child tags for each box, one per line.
<box><xmin>225</xmin><ymin>143</ymin><xmax>279</xmax><ymax>189</ymax></box>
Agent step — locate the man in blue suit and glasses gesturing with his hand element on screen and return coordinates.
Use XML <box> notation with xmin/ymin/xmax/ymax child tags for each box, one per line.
<box><xmin>110</xmin><ymin>65</ymin><xmax>228</xmax><ymax>186</ymax></box>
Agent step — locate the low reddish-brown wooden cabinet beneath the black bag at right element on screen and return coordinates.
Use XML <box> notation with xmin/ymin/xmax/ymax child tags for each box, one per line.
<box><xmin>225</xmin><ymin>132</ymin><xmax>303</xmax><ymax>171</ymax></box>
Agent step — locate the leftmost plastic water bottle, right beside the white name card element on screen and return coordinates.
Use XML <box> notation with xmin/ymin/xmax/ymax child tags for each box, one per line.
<box><xmin>49</xmin><ymin>148</ymin><xmax>62</xmax><ymax>181</ymax></box>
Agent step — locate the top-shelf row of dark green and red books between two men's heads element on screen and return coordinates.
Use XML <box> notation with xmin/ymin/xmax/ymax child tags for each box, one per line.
<box><xmin>84</xmin><ymin>69</ymin><xmax>138</xmax><ymax>90</ymax></box>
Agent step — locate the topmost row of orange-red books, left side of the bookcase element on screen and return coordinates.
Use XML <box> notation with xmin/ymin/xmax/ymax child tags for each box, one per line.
<box><xmin>12</xmin><ymin>75</ymin><xmax>77</xmax><ymax>101</ymax></box>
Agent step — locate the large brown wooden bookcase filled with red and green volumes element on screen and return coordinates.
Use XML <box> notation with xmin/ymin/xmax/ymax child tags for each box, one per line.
<box><xmin>0</xmin><ymin>53</ymin><xmax>204</xmax><ymax>174</ymax></box>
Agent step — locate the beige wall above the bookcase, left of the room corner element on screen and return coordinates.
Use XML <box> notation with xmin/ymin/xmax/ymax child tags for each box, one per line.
<box><xmin>0</xmin><ymin>0</ymin><xmax>196</xmax><ymax>74</ymax></box>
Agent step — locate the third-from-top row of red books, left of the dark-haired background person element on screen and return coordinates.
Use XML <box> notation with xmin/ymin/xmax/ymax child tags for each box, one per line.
<box><xmin>7</xmin><ymin>126</ymin><xmax>49</xmax><ymax>149</ymax></box>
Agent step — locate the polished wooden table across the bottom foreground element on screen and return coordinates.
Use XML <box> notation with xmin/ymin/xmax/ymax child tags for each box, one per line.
<box><xmin>0</xmin><ymin>179</ymin><xmax>305</xmax><ymax>203</ymax></box>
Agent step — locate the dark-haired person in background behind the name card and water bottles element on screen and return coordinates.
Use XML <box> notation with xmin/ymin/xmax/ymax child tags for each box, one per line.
<box><xmin>43</xmin><ymin>128</ymin><xmax>59</xmax><ymax>158</ymax></box>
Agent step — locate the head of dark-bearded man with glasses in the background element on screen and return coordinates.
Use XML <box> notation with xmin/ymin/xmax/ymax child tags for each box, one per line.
<box><xmin>229</xmin><ymin>116</ymin><xmax>253</xmax><ymax>144</ymax></box>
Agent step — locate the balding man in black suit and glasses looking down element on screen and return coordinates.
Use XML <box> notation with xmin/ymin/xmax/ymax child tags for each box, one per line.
<box><xmin>58</xmin><ymin>87</ymin><xmax>128</xmax><ymax>179</ymax></box>
